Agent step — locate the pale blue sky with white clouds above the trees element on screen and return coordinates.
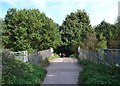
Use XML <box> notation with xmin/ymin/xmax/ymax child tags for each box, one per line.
<box><xmin>0</xmin><ymin>0</ymin><xmax>119</xmax><ymax>26</ymax></box>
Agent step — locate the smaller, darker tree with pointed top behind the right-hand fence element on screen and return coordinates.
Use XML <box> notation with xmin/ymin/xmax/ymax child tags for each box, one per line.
<box><xmin>95</xmin><ymin>20</ymin><xmax>117</xmax><ymax>48</ymax></box>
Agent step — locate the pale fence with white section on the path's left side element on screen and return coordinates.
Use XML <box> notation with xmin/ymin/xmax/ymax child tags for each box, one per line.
<box><xmin>10</xmin><ymin>48</ymin><xmax>53</xmax><ymax>64</ymax></box>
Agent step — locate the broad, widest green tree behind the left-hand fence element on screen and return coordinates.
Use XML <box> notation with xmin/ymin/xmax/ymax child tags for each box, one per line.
<box><xmin>2</xmin><ymin>8</ymin><xmax>61</xmax><ymax>52</ymax></box>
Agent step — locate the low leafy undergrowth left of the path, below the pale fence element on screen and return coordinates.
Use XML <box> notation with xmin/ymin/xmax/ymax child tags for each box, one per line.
<box><xmin>2</xmin><ymin>51</ymin><xmax>46</xmax><ymax>85</ymax></box>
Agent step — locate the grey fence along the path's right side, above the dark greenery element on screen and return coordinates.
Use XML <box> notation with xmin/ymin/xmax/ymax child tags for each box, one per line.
<box><xmin>78</xmin><ymin>49</ymin><xmax>120</xmax><ymax>66</ymax></box>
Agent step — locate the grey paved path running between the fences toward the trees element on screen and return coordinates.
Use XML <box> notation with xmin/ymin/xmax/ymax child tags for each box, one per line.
<box><xmin>42</xmin><ymin>58</ymin><xmax>81</xmax><ymax>86</ymax></box>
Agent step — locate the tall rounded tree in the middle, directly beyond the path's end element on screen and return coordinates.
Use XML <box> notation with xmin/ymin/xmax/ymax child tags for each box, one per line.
<box><xmin>60</xmin><ymin>10</ymin><xmax>92</xmax><ymax>53</ymax></box>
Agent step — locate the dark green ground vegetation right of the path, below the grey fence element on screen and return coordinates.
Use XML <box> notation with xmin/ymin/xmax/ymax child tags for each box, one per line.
<box><xmin>79</xmin><ymin>59</ymin><xmax>120</xmax><ymax>86</ymax></box>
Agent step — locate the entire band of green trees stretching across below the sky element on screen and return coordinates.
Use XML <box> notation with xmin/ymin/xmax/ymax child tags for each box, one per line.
<box><xmin>0</xmin><ymin>8</ymin><xmax>120</xmax><ymax>56</ymax></box>
